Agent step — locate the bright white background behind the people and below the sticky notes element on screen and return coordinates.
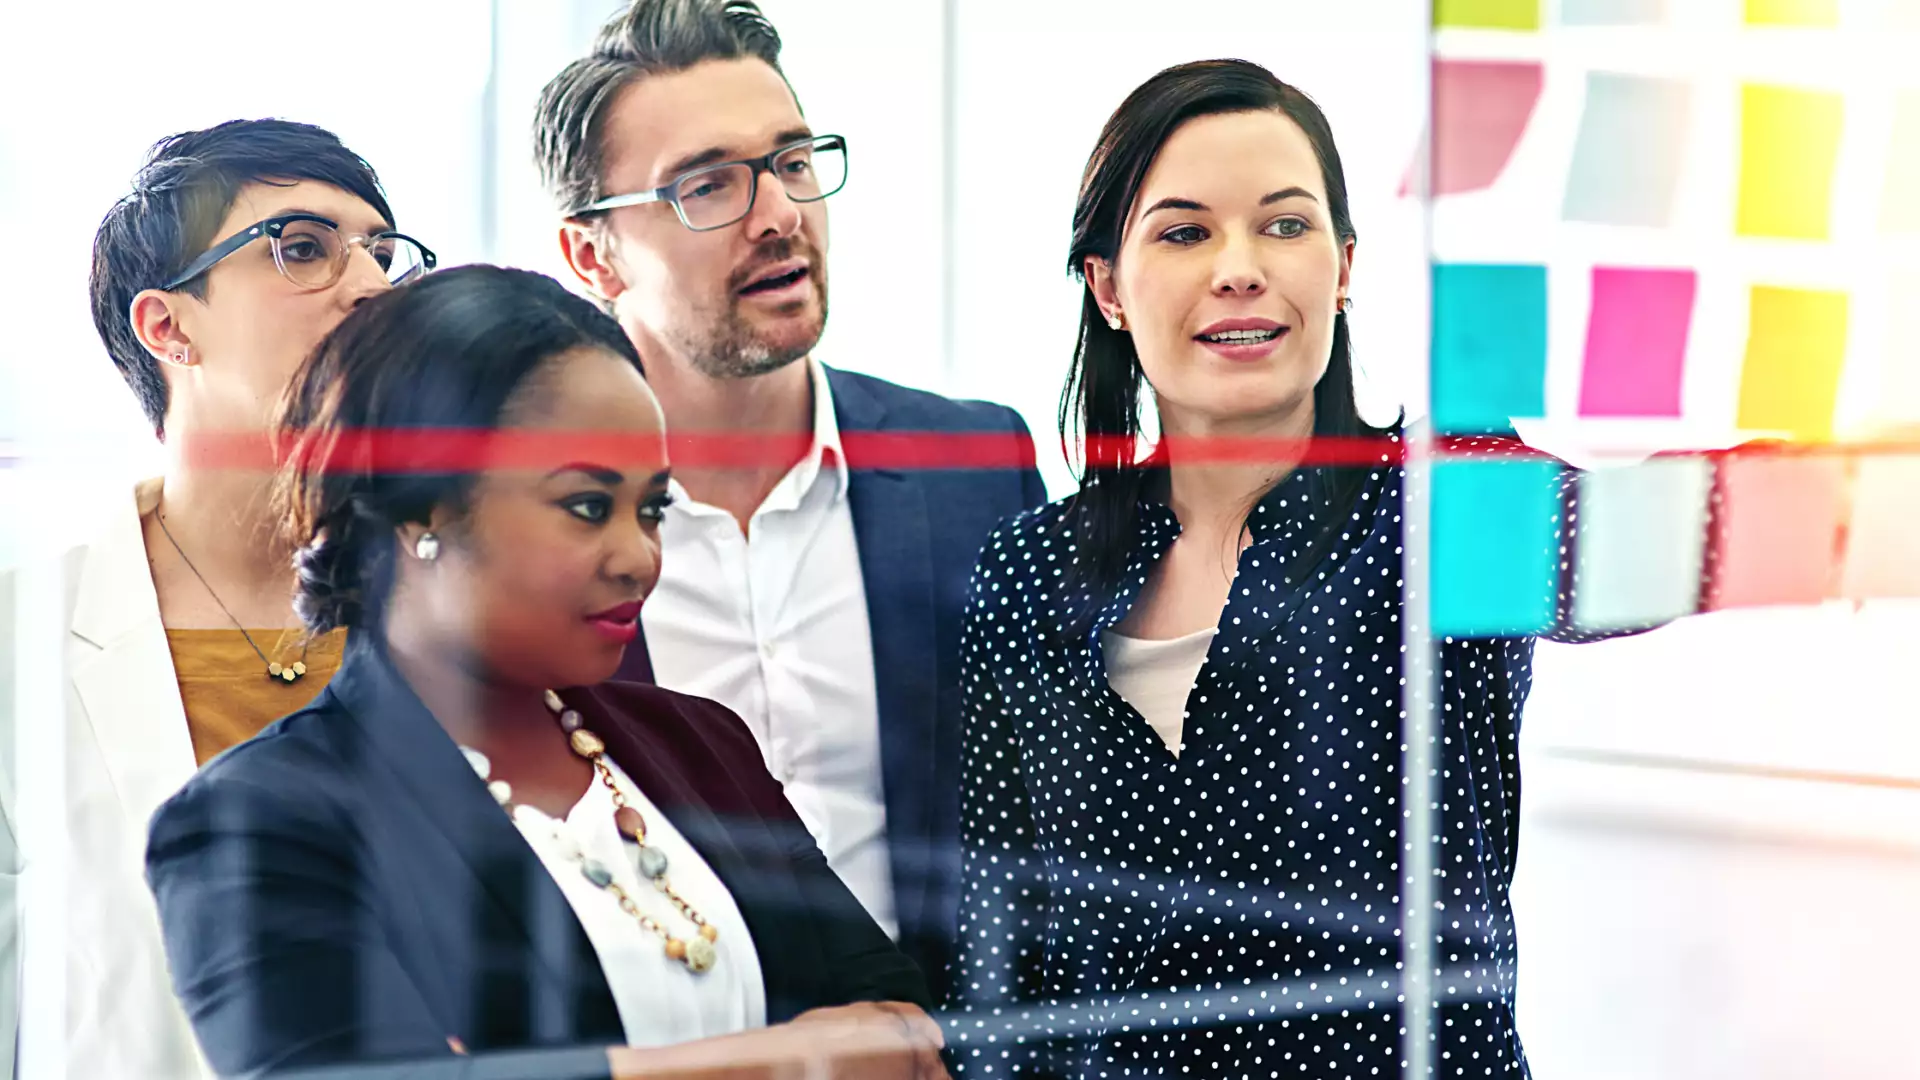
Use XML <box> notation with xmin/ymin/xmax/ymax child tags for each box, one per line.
<box><xmin>0</xmin><ymin>0</ymin><xmax>1920</xmax><ymax>1080</ymax></box>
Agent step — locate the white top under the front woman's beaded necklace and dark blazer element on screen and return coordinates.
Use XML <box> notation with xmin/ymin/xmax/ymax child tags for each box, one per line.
<box><xmin>513</xmin><ymin>761</ymin><xmax>766</xmax><ymax>1047</ymax></box>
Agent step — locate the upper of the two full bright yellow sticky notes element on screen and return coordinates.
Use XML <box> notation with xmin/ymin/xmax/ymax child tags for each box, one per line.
<box><xmin>1734</xmin><ymin>85</ymin><xmax>1841</xmax><ymax>240</ymax></box>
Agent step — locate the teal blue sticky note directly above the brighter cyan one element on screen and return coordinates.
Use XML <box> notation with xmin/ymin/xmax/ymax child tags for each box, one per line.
<box><xmin>1432</xmin><ymin>263</ymin><xmax>1548</xmax><ymax>434</ymax></box>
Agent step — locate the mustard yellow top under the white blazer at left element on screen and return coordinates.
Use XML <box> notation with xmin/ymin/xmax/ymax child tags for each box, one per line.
<box><xmin>167</xmin><ymin>630</ymin><xmax>346</xmax><ymax>765</ymax></box>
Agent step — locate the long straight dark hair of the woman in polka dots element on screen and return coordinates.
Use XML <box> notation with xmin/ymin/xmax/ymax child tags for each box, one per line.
<box><xmin>1060</xmin><ymin>60</ymin><xmax>1384</xmax><ymax>621</ymax></box>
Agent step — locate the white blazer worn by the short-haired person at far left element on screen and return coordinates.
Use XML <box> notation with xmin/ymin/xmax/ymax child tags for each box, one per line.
<box><xmin>0</xmin><ymin>480</ymin><xmax>213</xmax><ymax>1080</ymax></box>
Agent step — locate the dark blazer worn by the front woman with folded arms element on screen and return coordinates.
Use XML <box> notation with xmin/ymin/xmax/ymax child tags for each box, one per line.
<box><xmin>148</xmin><ymin>634</ymin><xmax>927</xmax><ymax>1078</ymax></box>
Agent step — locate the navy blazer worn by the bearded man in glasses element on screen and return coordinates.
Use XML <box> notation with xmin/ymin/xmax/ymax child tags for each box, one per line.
<box><xmin>616</xmin><ymin>367</ymin><xmax>1046</xmax><ymax>999</ymax></box>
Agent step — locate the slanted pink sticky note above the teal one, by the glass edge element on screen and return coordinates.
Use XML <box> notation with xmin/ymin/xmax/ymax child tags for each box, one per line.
<box><xmin>1400</xmin><ymin>60</ymin><xmax>1542</xmax><ymax>196</ymax></box>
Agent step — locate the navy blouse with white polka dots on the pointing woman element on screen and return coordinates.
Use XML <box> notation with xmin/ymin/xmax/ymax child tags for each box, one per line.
<box><xmin>948</xmin><ymin>432</ymin><xmax>1605</xmax><ymax>1080</ymax></box>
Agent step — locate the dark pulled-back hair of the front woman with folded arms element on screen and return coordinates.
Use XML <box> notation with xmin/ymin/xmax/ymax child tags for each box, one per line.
<box><xmin>275</xmin><ymin>265</ymin><xmax>639</xmax><ymax>634</ymax></box>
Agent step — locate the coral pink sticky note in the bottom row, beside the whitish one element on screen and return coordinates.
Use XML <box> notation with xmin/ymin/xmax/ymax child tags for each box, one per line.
<box><xmin>1707</xmin><ymin>454</ymin><xmax>1847</xmax><ymax>609</ymax></box>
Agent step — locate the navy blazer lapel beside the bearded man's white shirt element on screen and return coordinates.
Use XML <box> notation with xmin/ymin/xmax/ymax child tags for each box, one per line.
<box><xmin>828</xmin><ymin>367</ymin><xmax>943</xmax><ymax>941</ymax></box>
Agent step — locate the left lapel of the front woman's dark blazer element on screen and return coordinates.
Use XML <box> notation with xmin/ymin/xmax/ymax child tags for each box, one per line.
<box><xmin>326</xmin><ymin>636</ymin><xmax>622</xmax><ymax>1042</ymax></box>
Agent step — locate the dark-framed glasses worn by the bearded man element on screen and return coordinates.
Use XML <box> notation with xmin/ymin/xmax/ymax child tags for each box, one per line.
<box><xmin>568</xmin><ymin>135</ymin><xmax>847</xmax><ymax>233</ymax></box>
